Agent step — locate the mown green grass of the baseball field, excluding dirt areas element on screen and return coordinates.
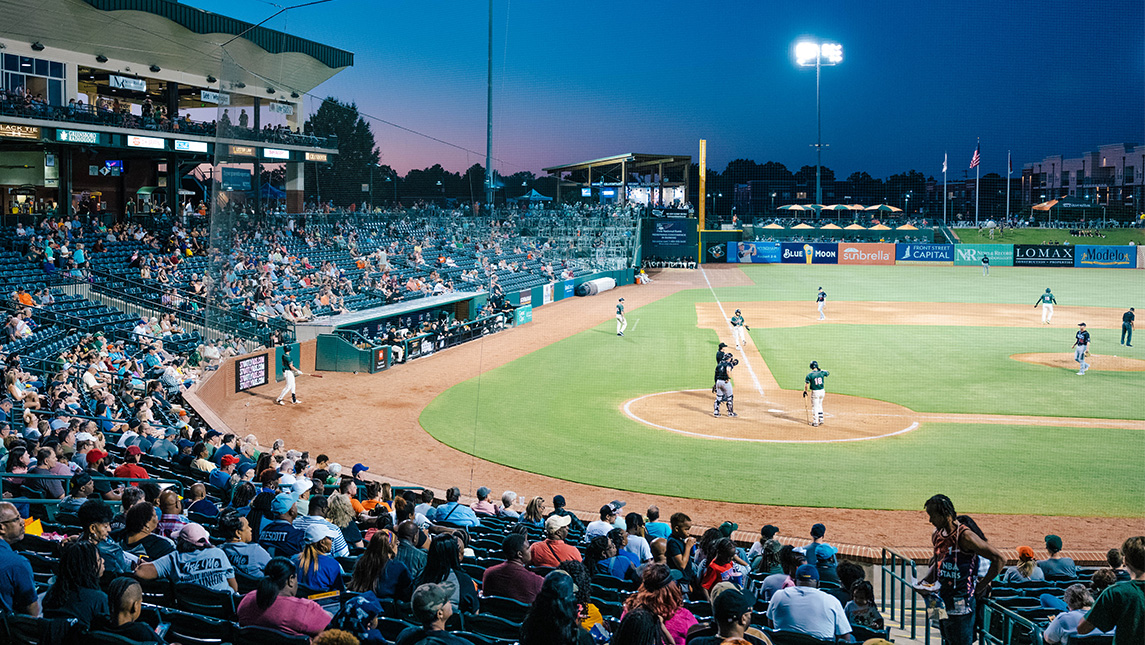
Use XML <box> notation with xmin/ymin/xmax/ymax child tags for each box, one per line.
<box><xmin>420</xmin><ymin>266</ymin><xmax>1145</xmax><ymax>517</ymax></box>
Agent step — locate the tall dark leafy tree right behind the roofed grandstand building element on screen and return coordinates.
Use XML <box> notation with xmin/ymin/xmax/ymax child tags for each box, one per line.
<box><xmin>306</xmin><ymin>96</ymin><xmax>381</xmax><ymax>206</ymax></box>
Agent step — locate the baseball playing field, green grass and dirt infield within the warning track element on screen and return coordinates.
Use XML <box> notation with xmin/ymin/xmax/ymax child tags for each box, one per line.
<box><xmin>419</xmin><ymin>265</ymin><xmax>1145</xmax><ymax>518</ymax></box>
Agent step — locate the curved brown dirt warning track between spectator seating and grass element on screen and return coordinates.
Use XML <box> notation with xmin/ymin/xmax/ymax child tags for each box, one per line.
<box><xmin>204</xmin><ymin>265</ymin><xmax>1142</xmax><ymax>552</ymax></box>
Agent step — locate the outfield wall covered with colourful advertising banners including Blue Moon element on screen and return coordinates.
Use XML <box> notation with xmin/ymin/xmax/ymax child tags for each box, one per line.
<box><xmin>726</xmin><ymin>242</ymin><xmax>1145</xmax><ymax>269</ymax></box>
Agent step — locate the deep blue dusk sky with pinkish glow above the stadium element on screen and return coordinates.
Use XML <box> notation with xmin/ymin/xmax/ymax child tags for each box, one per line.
<box><xmin>188</xmin><ymin>0</ymin><xmax>1145</xmax><ymax>179</ymax></box>
